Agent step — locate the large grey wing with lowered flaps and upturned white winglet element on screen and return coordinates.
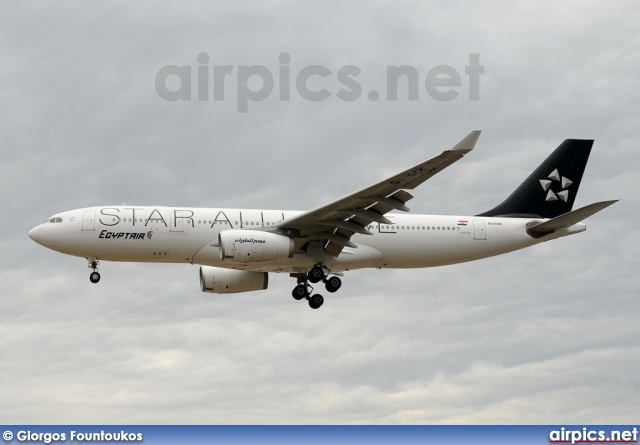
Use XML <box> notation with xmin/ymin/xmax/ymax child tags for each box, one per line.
<box><xmin>277</xmin><ymin>130</ymin><xmax>480</xmax><ymax>257</ymax></box>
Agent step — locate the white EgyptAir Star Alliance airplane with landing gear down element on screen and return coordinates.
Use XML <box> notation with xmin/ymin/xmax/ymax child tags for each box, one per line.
<box><xmin>29</xmin><ymin>130</ymin><xmax>617</xmax><ymax>309</ymax></box>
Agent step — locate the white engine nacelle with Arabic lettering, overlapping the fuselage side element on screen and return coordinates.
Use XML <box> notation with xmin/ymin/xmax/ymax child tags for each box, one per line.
<box><xmin>218</xmin><ymin>230</ymin><xmax>293</xmax><ymax>263</ymax></box>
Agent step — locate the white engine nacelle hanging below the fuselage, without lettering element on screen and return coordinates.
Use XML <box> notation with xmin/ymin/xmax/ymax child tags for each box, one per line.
<box><xmin>200</xmin><ymin>266</ymin><xmax>269</xmax><ymax>294</ymax></box>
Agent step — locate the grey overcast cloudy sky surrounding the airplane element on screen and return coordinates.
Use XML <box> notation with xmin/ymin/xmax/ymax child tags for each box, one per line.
<box><xmin>0</xmin><ymin>1</ymin><xmax>640</xmax><ymax>424</ymax></box>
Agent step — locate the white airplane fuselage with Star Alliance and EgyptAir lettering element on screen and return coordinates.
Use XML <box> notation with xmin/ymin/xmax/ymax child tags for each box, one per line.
<box><xmin>29</xmin><ymin>206</ymin><xmax>585</xmax><ymax>273</ymax></box>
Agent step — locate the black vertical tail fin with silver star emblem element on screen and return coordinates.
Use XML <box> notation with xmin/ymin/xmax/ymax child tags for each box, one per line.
<box><xmin>478</xmin><ymin>139</ymin><xmax>593</xmax><ymax>218</ymax></box>
